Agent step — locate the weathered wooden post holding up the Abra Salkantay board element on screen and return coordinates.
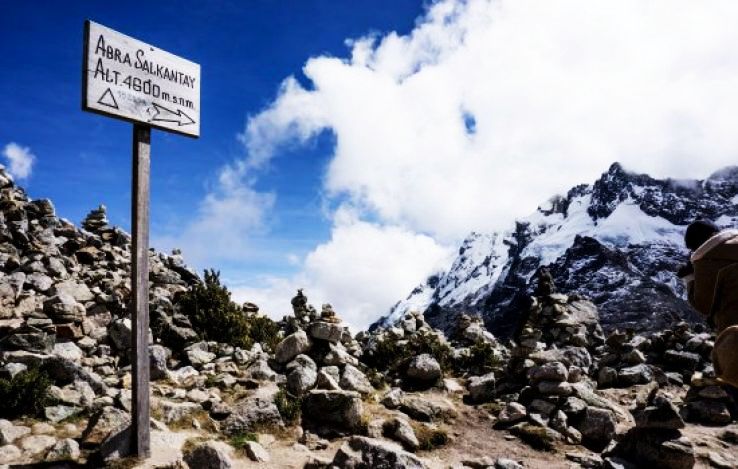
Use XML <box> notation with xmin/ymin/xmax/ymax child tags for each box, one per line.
<box><xmin>131</xmin><ymin>124</ymin><xmax>151</xmax><ymax>458</ymax></box>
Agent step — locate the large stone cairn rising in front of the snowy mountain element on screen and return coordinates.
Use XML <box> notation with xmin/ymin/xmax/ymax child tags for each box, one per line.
<box><xmin>484</xmin><ymin>271</ymin><xmax>627</xmax><ymax>451</ymax></box>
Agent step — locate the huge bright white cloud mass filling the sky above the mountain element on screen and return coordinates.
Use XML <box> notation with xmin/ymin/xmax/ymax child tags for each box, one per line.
<box><xmin>211</xmin><ymin>0</ymin><xmax>738</xmax><ymax>325</ymax></box>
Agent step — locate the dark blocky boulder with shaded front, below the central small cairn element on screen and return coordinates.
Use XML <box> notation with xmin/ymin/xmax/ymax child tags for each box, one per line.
<box><xmin>302</xmin><ymin>390</ymin><xmax>364</xmax><ymax>432</ymax></box>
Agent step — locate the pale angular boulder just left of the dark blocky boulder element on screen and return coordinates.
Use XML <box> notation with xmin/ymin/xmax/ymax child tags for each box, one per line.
<box><xmin>221</xmin><ymin>388</ymin><xmax>282</xmax><ymax>435</ymax></box>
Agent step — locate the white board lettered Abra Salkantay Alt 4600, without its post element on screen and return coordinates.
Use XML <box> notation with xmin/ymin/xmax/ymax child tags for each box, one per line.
<box><xmin>82</xmin><ymin>21</ymin><xmax>200</xmax><ymax>137</ymax></box>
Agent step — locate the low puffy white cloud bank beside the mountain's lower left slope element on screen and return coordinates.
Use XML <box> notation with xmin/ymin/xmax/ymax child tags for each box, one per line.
<box><xmin>233</xmin><ymin>210</ymin><xmax>452</xmax><ymax>330</ymax></box>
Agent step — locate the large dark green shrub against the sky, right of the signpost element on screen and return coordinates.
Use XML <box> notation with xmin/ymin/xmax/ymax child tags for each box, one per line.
<box><xmin>177</xmin><ymin>270</ymin><xmax>280</xmax><ymax>349</ymax></box>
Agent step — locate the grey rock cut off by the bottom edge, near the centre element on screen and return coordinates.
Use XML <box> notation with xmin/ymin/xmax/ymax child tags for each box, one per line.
<box><xmin>331</xmin><ymin>436</ymin><xmax>427</xmax><ymax>469</ymax></box>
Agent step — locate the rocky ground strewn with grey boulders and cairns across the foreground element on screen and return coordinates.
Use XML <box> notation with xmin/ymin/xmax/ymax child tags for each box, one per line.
<box><xmin>0</xmin><ymin>168</ymin><xmax>738</xmax><ymax>468</ymax></box>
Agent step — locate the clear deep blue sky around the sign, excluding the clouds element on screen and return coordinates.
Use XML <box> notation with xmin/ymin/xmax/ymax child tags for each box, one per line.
<box><xmin>0</xmin><ymin>0</ymin><xmax>422</xmax><ymax>276</ymax></box>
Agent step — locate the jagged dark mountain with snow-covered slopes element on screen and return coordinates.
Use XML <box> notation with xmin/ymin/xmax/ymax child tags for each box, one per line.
<box><xmin>377</xmin><ymin>163</ymin><xmax>738</xmax><ymax>336</ymax></box>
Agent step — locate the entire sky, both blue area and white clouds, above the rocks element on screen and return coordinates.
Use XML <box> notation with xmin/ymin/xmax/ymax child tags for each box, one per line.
<box><xmin>0</xmin><ymin>0</ymin><xmax>738</xmax><ymax>327</ymax></box>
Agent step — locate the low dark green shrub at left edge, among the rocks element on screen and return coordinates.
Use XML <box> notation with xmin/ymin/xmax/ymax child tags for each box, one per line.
<box><xmin>0</xmin><ymin>367</ymin><xmax>51</xmax><ymax>420</ymax></box>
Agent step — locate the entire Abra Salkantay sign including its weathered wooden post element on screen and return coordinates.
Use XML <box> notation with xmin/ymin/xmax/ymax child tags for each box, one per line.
<box><xmin>82</xmin><ymin>21</ymin><xmax>200</xmax><ymax>457</ymax></box>
